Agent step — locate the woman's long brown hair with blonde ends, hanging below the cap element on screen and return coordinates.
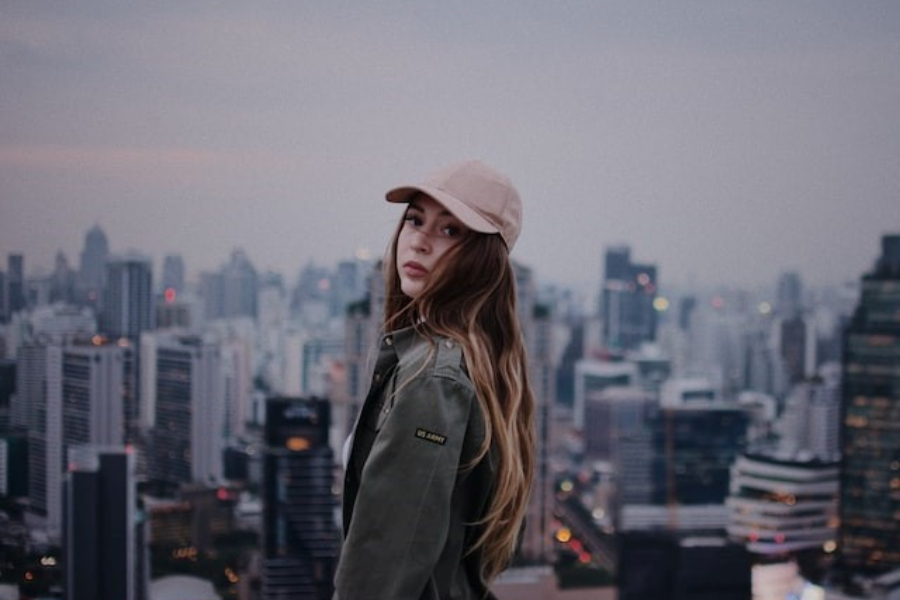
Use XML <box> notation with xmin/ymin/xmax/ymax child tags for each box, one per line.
<box><xmin>384</xmin><ymin>212</ymin><xmax>535</xmax><ymax>581</ymax></box>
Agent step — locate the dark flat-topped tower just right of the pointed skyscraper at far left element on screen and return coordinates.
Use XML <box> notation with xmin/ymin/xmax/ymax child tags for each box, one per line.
<box><xmin>100</xmin><ymin>254</ymin><xmax>156</xmax><ymax>340</ymax></box>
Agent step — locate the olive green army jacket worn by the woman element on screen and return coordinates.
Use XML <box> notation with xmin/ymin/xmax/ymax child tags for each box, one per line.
<box><xmin>334</xmin><ymin>328</ymin><xmax>496</xmax><ymax>600</ymax></box>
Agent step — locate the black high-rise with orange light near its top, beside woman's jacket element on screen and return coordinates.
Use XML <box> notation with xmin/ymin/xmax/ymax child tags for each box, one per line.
<box><xmin>261</xmin><ymin>397</ymin><xmax>340</xmax><ymax>600</ymax></box>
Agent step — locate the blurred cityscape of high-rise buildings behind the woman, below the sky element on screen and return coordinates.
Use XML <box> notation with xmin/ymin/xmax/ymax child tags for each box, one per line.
<box><xmin>0</xmin><ymin>226</ymin><xmax>900</xmax><ymax>600</ymax></box>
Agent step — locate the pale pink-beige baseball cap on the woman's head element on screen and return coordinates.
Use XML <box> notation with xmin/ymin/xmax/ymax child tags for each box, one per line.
<box><xmin>385</xmin><ymin>160</ymin><xmax>522</xmax><ymax>252</ymax></box>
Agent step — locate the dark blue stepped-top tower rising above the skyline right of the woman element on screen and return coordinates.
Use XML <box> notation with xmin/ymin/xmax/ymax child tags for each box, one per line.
<box><xmin>600</xmin><ymin>246</ymin><xmax>658</xmax><ymax>351</ymax></box>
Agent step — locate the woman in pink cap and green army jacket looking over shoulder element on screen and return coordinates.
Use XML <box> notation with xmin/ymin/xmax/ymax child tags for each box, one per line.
<box><xmin>335</xmin><ymin>161</ymin><xmax>534</xmax><ymax>600</ymax></box>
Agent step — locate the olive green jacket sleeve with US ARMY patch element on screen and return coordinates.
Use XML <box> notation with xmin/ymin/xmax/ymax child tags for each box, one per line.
<box><xmin>335</xmin><ymin>372</ymin><xmax>475</xmax><ymax>600</ymax></box>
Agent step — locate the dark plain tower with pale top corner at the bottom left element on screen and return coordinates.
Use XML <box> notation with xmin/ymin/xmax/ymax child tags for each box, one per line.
<box><xmin>63</xmin><ymin>446</ymin><xmax>146</xmax><ymax>600</ymax></box>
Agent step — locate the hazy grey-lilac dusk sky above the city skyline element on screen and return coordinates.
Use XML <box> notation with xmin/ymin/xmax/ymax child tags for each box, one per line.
<box><xmin>0</xmin><ymin>0</ymin><xmax>900</xmax><ymax>298</ymax></box>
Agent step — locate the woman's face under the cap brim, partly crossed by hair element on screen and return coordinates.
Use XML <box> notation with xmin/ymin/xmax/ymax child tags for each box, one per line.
<box><xmin>397</xmin><ymin>195</ymin><xmax>470</xmax><ymax>298</ymax></box>
